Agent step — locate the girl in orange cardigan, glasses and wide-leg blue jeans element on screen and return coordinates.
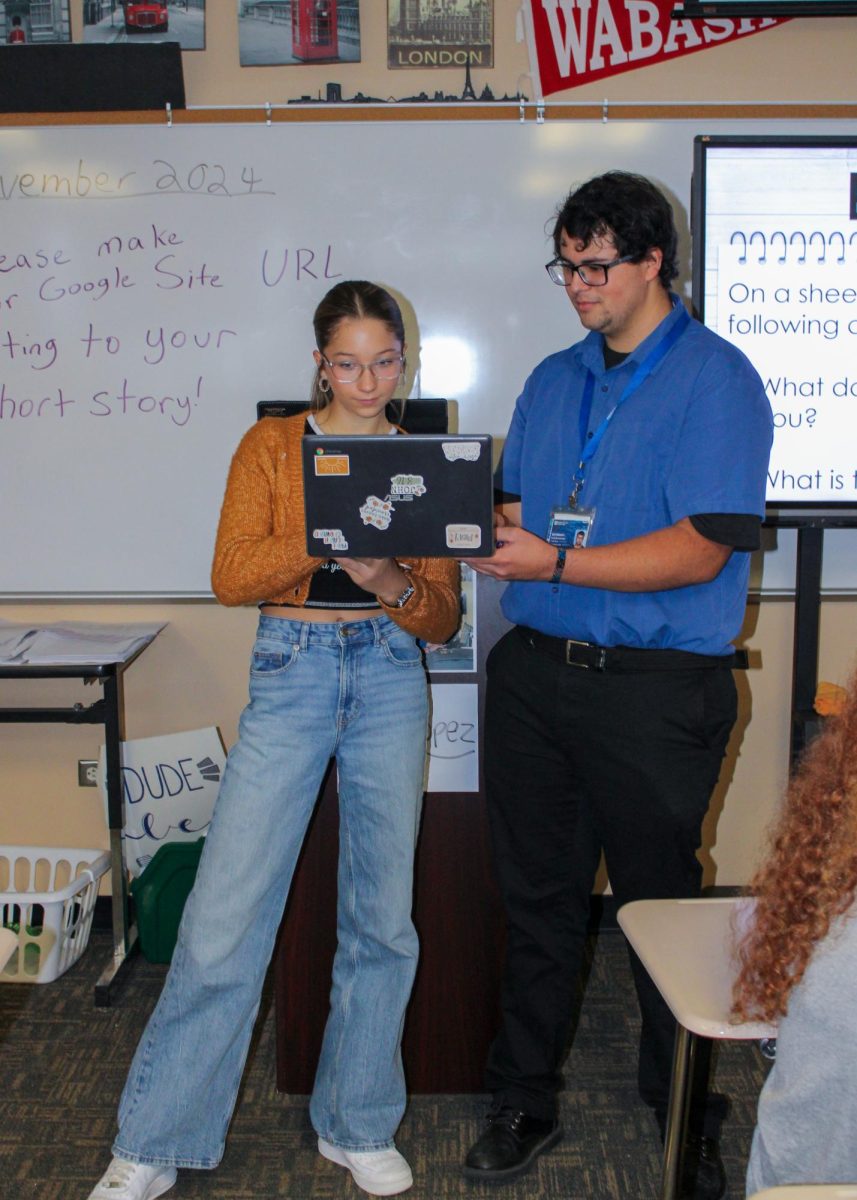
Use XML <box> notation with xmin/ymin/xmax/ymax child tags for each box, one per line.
<box><xmin>90</xmin><ymin>282</ymin><xmax>460</xmax><ymax>1200</ymax></box>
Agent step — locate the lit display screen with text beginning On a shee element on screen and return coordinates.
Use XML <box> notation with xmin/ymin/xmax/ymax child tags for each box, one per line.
<box><xmin>691</xmin><ymin>136</ymin><xmax>857</xmax><ymax>509</ymax></box>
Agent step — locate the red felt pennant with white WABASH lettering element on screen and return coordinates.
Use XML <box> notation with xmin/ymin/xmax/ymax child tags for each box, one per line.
<box><xmin>526</xmin><ymin>0</ymin><xmax>787</xmax><ymax>96</ymax></box>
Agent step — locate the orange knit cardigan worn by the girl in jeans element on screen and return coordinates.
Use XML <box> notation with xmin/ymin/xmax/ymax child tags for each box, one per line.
<box><xmin>211</xmin><ymin>413</ymin><xmax>461</xmax><ymax>642</ymax></box>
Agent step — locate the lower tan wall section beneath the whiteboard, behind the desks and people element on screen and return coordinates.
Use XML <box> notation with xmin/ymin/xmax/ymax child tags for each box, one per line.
<box><xmin>0</xmin><ymin>600</ymin><xmax>857</xmax><ymax>884</ymax></box>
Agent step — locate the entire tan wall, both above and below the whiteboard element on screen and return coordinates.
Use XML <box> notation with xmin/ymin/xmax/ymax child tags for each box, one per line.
<box><xmin>0</xmin><ymin>0</ymin><xmax>857</xmax><ymax>883</ymax></box>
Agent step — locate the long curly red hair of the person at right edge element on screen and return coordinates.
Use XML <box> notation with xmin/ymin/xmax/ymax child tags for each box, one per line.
<box><xmin>732</xmin><ymin>672</ymin><xmax>857</xmax><ymax>1021</ymax></box>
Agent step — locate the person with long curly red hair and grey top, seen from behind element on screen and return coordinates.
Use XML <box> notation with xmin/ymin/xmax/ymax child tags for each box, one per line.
<box><xmin>733</xmin><ymin>672</ymin><xmax>857</xmax><ymax>1196</ymax></box>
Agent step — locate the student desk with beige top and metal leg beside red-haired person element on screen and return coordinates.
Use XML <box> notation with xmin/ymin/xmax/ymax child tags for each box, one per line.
<box><xmin>618</xmin><ymin>896</ymin><xmax>772</xmax><ymax>1200</ymax></box>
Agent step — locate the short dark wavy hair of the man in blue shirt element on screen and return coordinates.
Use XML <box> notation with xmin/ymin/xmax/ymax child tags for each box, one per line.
<box><xmin>553</xmin><ymin>170</ymin><xmax>678</xmax><ymax>288</ymax></box>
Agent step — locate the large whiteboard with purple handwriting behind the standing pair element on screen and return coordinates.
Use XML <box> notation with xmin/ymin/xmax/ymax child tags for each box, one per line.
<box><xmin>0</xmin><ymin>119</ymin><xmax>857</xmax><ymax>599</ymax></box>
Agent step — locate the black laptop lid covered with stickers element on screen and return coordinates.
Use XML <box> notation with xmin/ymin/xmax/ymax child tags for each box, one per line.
<box><xmin>302</xmin><ymin>433</ymin><xmax>493</xmax><ymax>558</ymax></box>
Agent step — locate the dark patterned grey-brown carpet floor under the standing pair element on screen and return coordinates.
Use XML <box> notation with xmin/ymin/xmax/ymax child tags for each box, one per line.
<box><xmin>0</xmin><ymin>930</ymin><xmax>766</xmax><ymax>1200</ymax></box>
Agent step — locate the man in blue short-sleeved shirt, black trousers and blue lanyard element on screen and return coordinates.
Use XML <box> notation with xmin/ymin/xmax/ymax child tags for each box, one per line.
<box><xmin>465</xmin><ymin>172</ymin><xmax>772</xmax><ymax>1200</ymax></box>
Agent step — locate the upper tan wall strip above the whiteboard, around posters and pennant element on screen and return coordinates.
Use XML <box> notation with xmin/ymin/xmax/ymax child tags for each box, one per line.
<box><xmin>71</xmin><ymin>0</ymin><xmax>857</xmax><ymax>106</ymax></box>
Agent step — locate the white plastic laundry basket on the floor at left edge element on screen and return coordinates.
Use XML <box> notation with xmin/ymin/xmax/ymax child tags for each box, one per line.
<box><xmin>0</xmin><ymin>846</ymin><xmax>110</xmax><ymax>983</ymax></box>
